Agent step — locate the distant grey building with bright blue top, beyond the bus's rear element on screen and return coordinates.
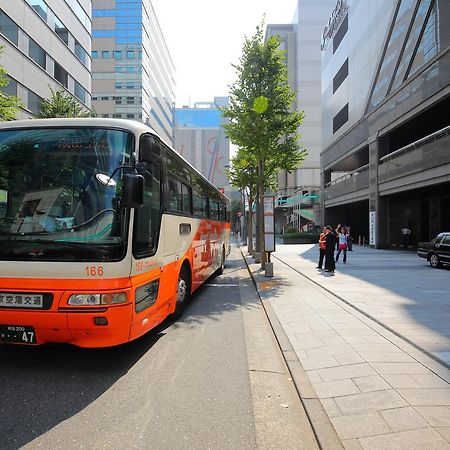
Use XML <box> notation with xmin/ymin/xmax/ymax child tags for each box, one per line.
<box><xmin>174</xmin><ymin>97</ymin><xmax>230</xmax><ymax>196</ymax></box>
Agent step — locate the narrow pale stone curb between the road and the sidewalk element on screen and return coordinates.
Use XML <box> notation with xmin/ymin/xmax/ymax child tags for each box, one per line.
<box><xmin>243</xmin><ymin>246</ymin><xmax>344</xmax><ymax>450</ymax></box>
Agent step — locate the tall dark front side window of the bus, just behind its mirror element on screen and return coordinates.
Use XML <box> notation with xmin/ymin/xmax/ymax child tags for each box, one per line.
<box><xmin>133</xmin><ymin>162</ymin><xmax>161</xmax><ymax>258</ymax></box>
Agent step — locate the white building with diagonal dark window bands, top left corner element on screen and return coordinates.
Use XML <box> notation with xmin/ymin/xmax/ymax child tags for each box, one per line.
<box><xmin>0</xmin><ymin>0</ymin><xmax>92</xmax><ymax>119</ymax></box>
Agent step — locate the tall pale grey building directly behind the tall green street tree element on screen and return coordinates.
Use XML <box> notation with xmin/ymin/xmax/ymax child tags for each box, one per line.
<box><xmin>266</xmin><ymin>0</ymin><xmax>336</xmax><ymax>228</ymax></box>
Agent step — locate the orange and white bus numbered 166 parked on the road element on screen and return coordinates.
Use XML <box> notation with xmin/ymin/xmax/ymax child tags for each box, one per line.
<box><xmin>0</xmin><ymin>118</ymin><xmax>230</xmax><ymax>347</ymax></box>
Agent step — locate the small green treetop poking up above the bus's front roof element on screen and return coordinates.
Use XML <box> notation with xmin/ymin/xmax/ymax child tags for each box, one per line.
<box><xmin>37</xmin><ymin>86</ymin><xmax>96</xmax><ymax>119</ymax></box>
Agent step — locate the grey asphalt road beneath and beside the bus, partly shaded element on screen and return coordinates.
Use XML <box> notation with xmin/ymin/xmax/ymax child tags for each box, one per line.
<box><xmin>0</xmin><ymin>250</ymin><xmax>316</xmax><ymax>450</ymax></box>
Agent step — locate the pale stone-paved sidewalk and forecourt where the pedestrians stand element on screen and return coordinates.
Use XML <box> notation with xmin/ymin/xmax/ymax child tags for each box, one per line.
<box><xmin>246</xmin><ymin>245</ymin><xmax>450</xmax><ymax>450</ymax></box>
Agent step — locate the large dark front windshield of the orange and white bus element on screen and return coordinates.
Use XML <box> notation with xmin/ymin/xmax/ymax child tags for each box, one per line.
<box><xmin>0</xmin><ymin>127</ymin><xmax>133</xmax><ymax>261</ymax></box>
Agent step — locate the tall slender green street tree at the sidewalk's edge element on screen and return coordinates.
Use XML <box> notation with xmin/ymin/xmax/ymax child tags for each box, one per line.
<box><xmin>223</xmin><ymin>24</ymin><xmax>307</xmax><ymax>265</ymax></box>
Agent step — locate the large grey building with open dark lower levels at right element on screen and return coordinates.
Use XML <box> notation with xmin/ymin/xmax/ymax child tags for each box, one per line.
<box><xmin>321</xmin><ymin>0</ymin><xmax>450</xmax><ymax>247</ymax></box>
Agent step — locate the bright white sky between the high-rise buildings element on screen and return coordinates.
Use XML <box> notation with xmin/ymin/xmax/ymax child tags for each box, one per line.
<box><xmin>151</xmin><ymin>0</ymin><xmax>297</xmax><ymax>107</ymax></box>
